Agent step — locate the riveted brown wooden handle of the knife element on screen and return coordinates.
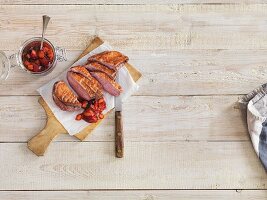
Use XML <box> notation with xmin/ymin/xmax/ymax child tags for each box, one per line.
<box><xmin>115</xmin><ymin>111</ymin><xmax>124</xmax><ymax>158</ymax></box>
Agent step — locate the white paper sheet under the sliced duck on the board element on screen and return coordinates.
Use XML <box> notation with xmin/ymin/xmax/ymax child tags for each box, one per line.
<box><xmin>37</xmin><ymin>43</ymin><xmax>138</xmax><ymax>135</ymax></box>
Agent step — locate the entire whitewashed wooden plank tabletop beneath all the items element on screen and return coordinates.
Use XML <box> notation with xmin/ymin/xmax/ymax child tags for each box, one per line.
<box><xmin>0</xmin><ymin>0</ymin><xmax>267</xmax><ymax>200</ymax></box>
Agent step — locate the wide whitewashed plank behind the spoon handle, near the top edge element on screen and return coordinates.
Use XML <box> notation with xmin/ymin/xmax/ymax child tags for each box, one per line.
<box><xmin>0</xmin><ymin>4</ymin><xmax>267</xmax><ymax>50</ymax></box>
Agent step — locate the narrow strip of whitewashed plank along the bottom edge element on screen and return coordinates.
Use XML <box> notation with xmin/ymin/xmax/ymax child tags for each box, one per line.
<box><xmin>0</xmin><ymin>190</ymin><xmax>267</xmax><ymax>200</ymax></box>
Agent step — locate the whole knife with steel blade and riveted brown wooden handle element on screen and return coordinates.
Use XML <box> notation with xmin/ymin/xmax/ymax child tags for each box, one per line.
<box><xmin>115</xmin><ymin>73</ymin><xmax>124</xmax><ymax>158</ymax></box>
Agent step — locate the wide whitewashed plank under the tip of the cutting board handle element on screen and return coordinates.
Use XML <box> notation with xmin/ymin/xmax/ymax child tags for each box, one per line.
<box><xmin>0</xmin><ymin>141</ymin><xmax>267</xmax><ymax>190</ymax></box>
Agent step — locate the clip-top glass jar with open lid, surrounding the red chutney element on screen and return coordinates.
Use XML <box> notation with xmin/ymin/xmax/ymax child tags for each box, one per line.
<box><xmin>0</xmin><ymin>37</ymin><xmax>67</xmax><ymax>81</ymax></box>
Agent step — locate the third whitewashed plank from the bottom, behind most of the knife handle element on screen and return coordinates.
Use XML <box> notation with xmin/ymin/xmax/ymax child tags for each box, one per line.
<box><xmin>0</xmin><ymin>96</ymin><xmax>249</xmax><ymax>142</ymax></box>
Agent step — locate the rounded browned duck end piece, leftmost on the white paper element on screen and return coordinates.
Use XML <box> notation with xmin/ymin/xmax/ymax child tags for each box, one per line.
<box><xmin>52</xmin><ymin>81</ymin><xmax>81</xmax><ymax>111</ymax></box>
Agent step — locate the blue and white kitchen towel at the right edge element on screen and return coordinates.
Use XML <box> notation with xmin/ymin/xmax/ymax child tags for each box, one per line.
<box><xmin>239</xmin><ymin>84</ymin><xmax>267</xmax><ymax>170</ymax></box>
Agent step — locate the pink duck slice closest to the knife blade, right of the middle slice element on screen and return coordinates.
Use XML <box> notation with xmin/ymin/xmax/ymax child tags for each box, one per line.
<box><xmin>90</xmin><ymin>72</ymin><xmax>122</xmax><ymax>96</ymax></box>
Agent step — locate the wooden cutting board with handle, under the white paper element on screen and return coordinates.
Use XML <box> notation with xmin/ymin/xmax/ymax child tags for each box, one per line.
<box><xmin>28</xmin><ymin>37</ymin><xmax>142</xmax><ymax>156</ymax></box>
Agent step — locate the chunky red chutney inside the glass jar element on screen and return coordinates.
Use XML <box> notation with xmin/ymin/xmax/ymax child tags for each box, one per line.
<box><xmin>22</xmin><ymin>41</ymin><xmax>55</xmax><ymax>72</ymax></box>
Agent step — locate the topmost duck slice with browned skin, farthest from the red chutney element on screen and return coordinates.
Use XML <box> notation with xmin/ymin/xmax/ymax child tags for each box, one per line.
<box><xmin>88</xmin><ymin>51</ymin><xmax>129</xmax><ymax>71</ymax></box>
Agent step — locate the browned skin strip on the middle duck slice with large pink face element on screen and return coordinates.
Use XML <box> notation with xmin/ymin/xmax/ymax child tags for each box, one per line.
<box><xmin>70</xmin><ymin>66</ymin><xmax>103</xmax><ymax>99</ymax></box>
